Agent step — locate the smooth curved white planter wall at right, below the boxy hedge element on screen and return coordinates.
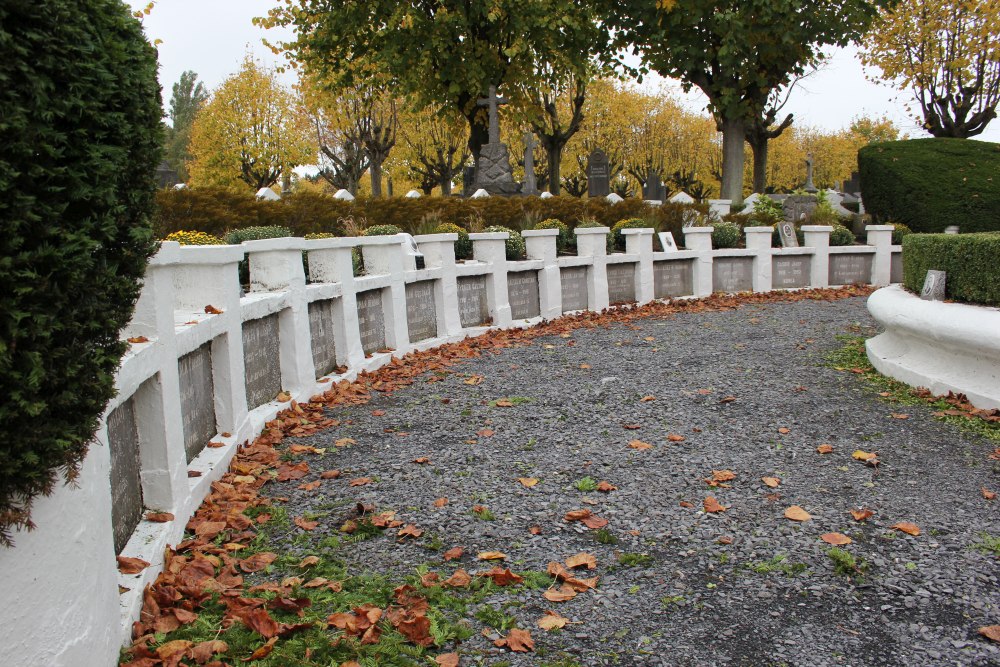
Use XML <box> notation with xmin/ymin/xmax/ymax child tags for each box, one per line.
<box><xmin>866</xmin><ymin>285</ymin><xmax>1000</xmax><ymax>409</ymax></box>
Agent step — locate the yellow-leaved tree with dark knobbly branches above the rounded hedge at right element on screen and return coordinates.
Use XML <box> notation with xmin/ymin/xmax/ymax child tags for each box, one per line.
<box><xmin>861</xmin><ymin>0</ymin><xmax>1000</xmax><ymax>138</ymax></box>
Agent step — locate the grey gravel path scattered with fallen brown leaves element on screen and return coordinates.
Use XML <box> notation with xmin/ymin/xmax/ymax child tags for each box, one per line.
<box><xmin>267</xmin><ymin>298</ymin><xmax>1000</xmax><ymax>666</ymax></box>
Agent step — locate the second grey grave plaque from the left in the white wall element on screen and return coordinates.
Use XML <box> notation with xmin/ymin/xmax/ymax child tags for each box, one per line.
<box><xmin>177</xmin><ymin>342</ymin><xmax>218</xmax><ymax>463</ymax></box>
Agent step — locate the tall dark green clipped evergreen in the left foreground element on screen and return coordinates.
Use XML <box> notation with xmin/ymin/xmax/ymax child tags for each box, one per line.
<box><xmin>0</xmin><ymin>0</ymin><xmax>163</xmax><ymax>545</ymax></box>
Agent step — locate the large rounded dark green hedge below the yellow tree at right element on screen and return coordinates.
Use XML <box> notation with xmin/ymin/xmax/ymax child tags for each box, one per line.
<box><xmin>858</xmin><ymin>139</ymin><xmax>1000</xmax><ymax>233</ymax></box>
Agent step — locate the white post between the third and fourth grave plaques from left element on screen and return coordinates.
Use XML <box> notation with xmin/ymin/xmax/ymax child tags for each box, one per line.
<box><xmin>243</xmin><ymin>238</ymin><xmax>316</xmax><ymax>393</ymax></box>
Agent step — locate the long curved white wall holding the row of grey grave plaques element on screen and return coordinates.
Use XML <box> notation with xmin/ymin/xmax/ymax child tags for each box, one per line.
<box><xmin>0</xmin><ymin>226</ymin><xmax>899</xmax><ymax>667</ymax></box>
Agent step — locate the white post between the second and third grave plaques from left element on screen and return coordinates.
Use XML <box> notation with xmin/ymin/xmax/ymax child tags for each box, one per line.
<box><xmin>174</xmin><ymin>246</ymin><xmax>247</xmax><ymax>433</ymax></box>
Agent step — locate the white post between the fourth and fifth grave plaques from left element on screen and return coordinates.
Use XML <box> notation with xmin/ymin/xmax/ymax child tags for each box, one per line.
<box><xmin>306</xmin><ymin>237</ymin><xmax>365</xmax><ymax>367</ymax></box>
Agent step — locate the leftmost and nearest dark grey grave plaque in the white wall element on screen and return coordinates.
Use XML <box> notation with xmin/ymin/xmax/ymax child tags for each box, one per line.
<box><xmin>108</xmin><ymin>397</ymin><xmax>143</xmax><ymax>554</ymax></box>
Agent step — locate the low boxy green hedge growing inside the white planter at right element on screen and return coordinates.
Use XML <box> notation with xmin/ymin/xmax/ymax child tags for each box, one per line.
<box><xmin>903</xmin><ymin>232</ymin><xmax>1000</xmax><ymax>306</ymax></box>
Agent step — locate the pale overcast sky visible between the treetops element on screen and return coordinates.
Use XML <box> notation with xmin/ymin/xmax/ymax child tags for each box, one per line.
<box><xmin>129</xmin><ymin>0</ymin><xmax>1000</xmax><ymax>142</ymax></box>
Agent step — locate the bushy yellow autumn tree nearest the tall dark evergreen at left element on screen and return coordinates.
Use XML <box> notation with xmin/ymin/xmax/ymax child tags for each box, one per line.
<box><xmin>188</xmin><ymin>55</ymin><xmax>314</xmax><ymax>191</ymax></box>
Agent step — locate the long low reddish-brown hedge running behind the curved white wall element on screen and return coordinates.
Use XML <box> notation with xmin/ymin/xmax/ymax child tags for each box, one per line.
<box><xmin>155</xmin><ymin>188</ymin><xmax>708</xmax><ymax>244</ymax></box>
